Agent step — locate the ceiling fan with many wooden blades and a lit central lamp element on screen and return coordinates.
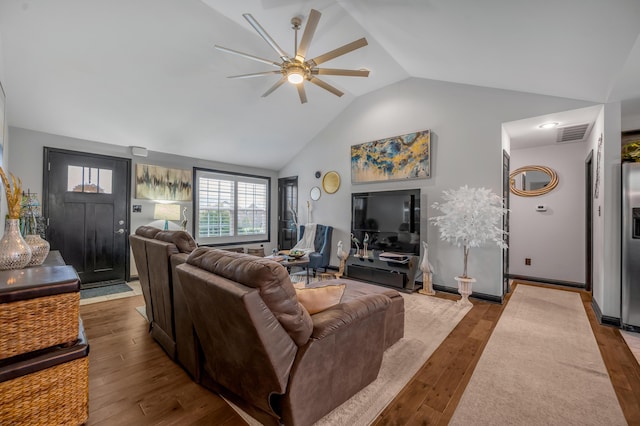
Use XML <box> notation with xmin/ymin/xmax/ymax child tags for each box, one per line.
<box><xmin>215</xmin><ymin>9</ymin><xmax>369</xmax><ymax>104</ymax></box>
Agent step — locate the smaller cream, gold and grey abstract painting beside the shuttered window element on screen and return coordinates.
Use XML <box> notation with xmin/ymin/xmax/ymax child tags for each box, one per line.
<box><xmin>136</xmin><ymin>164</ymin><xmax>193</xmax><ymax>201</ymax></box>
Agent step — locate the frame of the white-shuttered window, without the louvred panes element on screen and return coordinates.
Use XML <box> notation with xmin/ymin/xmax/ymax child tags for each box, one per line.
<box><xmin>193</xmin><ymin>167</ymin><xmax>271</xmax><ymax>247</ymax></box>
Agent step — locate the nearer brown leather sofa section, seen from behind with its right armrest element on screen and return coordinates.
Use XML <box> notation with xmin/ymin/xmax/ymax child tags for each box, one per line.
<box><xmin>175</xmin><ymin>247</ymin><xmax>404</xmax><ymax>425</ymax></box>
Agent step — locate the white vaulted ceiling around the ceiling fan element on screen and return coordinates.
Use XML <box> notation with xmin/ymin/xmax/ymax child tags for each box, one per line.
<box><xmin>0</xmin><ymin>0</ymin><xmax>640</xmax><ymax>170</ymax></box>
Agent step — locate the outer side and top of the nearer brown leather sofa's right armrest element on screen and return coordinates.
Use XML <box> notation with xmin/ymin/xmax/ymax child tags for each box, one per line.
<box><xmin>281</xmin><ymin>294</ymin><xmax>391</xmax><ymax>424</ymax></box>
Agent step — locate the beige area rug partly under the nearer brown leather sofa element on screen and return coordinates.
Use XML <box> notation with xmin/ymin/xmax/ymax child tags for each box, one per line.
<box><xmin>230</xmin><ymin>293</ymin><xmax>471</xmax><ymax>426</ymax></box>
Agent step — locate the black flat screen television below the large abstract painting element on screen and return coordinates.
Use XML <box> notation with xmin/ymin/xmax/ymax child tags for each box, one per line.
<box><xmin>351</xmin><ymin>189</ymin><xmax>420</xmax><ymax>256</ymax></box>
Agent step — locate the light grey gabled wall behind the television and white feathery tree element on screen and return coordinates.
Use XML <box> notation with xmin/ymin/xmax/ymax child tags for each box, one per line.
<box><xmin>280</xmin><ymin>78</ymin><xmax>592</xmax><ymax>296</ymax></box>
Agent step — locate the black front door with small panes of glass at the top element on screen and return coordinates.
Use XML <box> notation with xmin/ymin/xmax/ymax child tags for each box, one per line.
<box><xmin>43</xmin><ymin>147</ymin><xmax>131</xmax><ymax>288</ymax></box>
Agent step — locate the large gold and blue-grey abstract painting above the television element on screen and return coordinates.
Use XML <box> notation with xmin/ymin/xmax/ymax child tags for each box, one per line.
<box><xmin>351</xmin><ymin>130</ymin><xmax>431</xmax><ymax>183</ymax></box>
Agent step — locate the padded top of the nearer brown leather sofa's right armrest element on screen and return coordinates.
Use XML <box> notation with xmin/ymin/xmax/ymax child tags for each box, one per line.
<box><xmin>311</xmin><ymin>294</ymin><xmax>391</xmax><ymax>339</ymax></box>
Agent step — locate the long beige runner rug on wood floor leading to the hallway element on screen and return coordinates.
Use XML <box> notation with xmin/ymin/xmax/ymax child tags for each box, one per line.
<box><xmin>450</xmin><ymin>284</ymin><xmax>627</xmax><ymax>425</ymax></box>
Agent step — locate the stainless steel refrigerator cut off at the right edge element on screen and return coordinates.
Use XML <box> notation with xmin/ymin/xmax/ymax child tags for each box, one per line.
<box><xmin>622</xmin><ymin>163</ymin><xmax>640</xmax><ymax>331</ymax></box>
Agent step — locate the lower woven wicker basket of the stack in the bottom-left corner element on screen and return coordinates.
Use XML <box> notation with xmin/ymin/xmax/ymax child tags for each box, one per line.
<box><xmin>0</xmin><ymin>356</ymin><xmax>89</xmax><ymax>425</ymax></box>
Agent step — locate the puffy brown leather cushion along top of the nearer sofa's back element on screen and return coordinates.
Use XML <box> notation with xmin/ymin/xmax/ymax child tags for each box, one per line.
<box><xmin>187</xmin><ymin>247</ymin><xmax>313</xmax><ymax>346</ymax></box>
